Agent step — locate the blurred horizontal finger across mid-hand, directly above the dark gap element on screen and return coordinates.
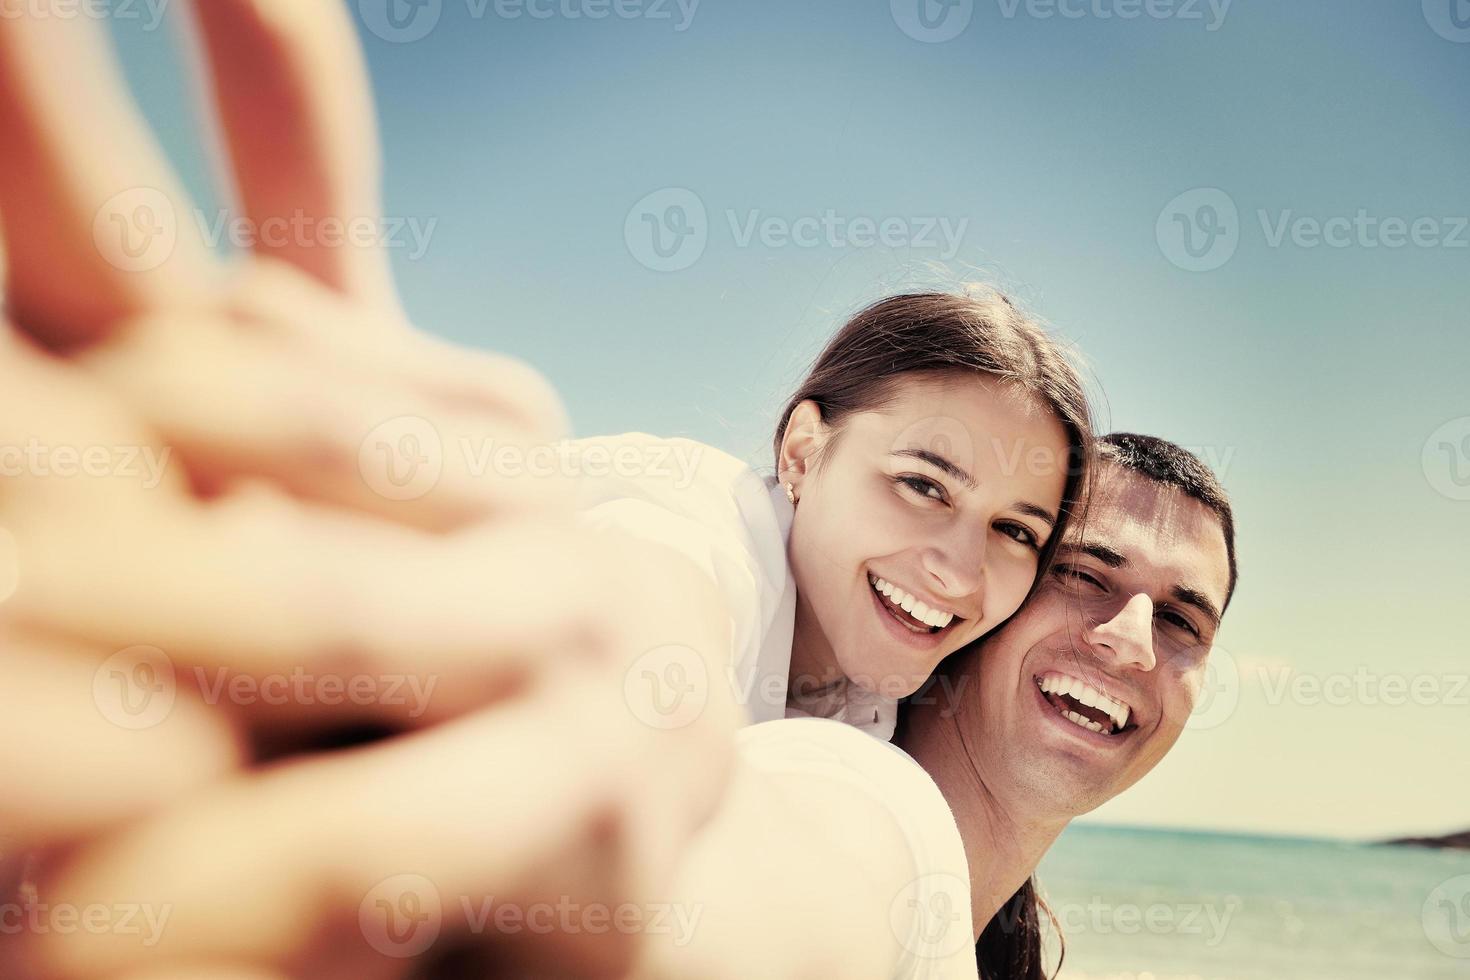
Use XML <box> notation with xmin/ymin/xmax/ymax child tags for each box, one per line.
<box><xmin>10</xmin><ymin>486</ymin><xmax>616</xmax><ymax>726</ymax></box>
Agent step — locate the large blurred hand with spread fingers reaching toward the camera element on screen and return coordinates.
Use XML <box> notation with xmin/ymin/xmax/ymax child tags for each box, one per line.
<box><xmin>0</xmin><ymin>0</ymin><xmax>738</xmax><ymax>977</ymax></box>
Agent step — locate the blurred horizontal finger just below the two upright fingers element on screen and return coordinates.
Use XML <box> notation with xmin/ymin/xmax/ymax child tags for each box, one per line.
<box><xmin>81</xmin><ymin>310</ymin><xmax>572</xmax><ymax>530</ymax></box>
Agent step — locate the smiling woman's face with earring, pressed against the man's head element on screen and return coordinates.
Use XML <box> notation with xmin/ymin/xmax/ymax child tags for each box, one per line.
<box><xmin>781</xmin><ymin>373</ymin><xmax>1070</xmax><ymax>698</ymax></box>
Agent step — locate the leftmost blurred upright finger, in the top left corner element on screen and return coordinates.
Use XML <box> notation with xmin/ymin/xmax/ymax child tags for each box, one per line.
<box><xmin>0</xmin><ymin>9</ymin><xmax>216</xmax><ymax>347</ymax></box>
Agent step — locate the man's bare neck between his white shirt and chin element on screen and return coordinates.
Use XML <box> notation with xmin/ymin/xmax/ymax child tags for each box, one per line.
<box><xmin>898</xmin><ymin>704</ymin><xmax>1067</xmax><ymax>937</ymax></box>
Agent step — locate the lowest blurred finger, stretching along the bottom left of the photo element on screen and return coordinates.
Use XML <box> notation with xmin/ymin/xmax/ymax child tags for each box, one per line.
<box><xmin>15</xmin><ymin>676</ymin><xmax>649</xmax><ymax>977</ymax></box>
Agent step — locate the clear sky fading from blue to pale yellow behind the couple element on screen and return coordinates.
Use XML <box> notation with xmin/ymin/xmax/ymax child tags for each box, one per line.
<box><xmin>108</xmin><ymin>0</ymin><xmax>1470</xmax><ymax>836</ymax></box>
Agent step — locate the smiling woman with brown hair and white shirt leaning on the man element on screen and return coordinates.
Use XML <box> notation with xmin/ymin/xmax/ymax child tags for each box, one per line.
<box><xmin>579</xmin><ymin>291</ymin><xmax>1091</xmax><ymax>739</ymax></box>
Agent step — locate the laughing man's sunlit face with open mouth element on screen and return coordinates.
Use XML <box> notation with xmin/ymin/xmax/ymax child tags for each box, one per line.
<box><xmin>960</xmin><ymin>463</ymin><xmax>1229</xmax><ymax>818</ymax></box>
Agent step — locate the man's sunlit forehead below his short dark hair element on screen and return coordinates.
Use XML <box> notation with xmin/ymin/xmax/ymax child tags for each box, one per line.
<box><xmin>1067</xmin><ymin>463</ymin><xmax>1230</xmax><ymax>608</ymax></box>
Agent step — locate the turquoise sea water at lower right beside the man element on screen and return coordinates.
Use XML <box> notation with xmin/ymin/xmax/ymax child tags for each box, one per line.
<box><xmin>1038</xmin><ymin>826</ymin><xmax>1470</xmax><ymax>980</ymax></box>
